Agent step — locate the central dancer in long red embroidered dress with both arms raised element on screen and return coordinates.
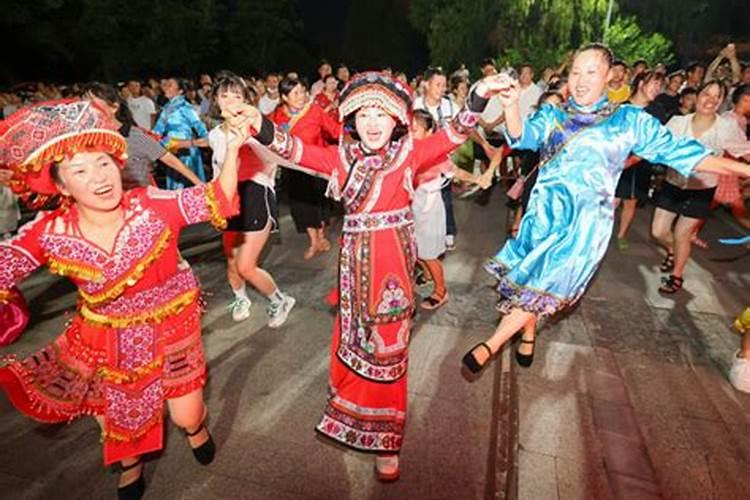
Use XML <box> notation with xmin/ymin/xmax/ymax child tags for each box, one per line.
<box><xmin>228</xmin><ymin>72</ymin><xmax>512</xmax><ymax>480</ymax></box>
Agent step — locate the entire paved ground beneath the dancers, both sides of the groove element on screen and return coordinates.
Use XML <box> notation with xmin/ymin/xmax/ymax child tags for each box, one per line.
<box><xmin>0</xmin><ymin>188</ymin><xmax>750</xmax><ymax>500</ymax></box>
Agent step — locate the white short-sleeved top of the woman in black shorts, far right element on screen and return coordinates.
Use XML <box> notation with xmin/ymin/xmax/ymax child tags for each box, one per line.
<box><xmin>667</xmin><ymin>113</ymin><xmax>750</xmax><ymax>189</ymax></box>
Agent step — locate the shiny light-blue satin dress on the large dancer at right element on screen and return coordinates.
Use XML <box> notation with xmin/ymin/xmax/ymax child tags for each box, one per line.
<box><xmin>485</xmin><ymin>97</ymin><xmax>710</xmax><ymax>316</ymax></box>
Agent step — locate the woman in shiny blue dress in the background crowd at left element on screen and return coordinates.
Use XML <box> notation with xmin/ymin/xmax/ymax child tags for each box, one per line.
<box><xmin>154</xmin><ymin>78</ymin><xmax>208</xmax><ymax>189</ymax></box>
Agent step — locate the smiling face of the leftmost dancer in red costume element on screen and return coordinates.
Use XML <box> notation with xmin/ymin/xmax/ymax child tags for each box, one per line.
<box><xmin>58</xmin><ymin>152</ymin><xmax>122</xmax><ymax>212</ymax></box>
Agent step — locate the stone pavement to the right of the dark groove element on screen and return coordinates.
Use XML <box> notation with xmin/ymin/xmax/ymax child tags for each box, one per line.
<box><xmin>516</xmin><ymin>205</ymin><xmax>750</xmax><ymax>500</ymax></box>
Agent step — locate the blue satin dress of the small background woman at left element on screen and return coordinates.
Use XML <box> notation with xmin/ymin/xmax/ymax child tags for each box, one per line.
<box><xmin>154</xmin><ymin>95</ymin><xmax>208</xmax><ymax>190</ymax></box>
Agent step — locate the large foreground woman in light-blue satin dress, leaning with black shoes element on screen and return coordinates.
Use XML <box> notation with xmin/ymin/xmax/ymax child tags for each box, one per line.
<box><xmin>463</xmin><ymin>44</ymin><xmax>750</xmax><ymax>372</ymax></box>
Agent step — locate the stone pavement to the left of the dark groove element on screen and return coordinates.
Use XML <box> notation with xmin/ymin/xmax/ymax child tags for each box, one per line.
<box><xmin>0</xmin><ymin>192</ymin><xmax>504</xmax><ymax>500</ymax></box>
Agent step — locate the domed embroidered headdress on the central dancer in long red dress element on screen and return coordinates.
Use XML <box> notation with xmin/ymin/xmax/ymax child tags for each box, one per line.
<box><xmin>339</xmin><ymin>71</ymin><xmax>412</xmax><ymax>127</ymax></box>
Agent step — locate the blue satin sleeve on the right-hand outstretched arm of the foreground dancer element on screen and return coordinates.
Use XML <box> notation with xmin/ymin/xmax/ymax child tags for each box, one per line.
<box><xmin>633</xmin><ymin>111</ymin><xmax>711</xmax><ymax>177</ymax></box>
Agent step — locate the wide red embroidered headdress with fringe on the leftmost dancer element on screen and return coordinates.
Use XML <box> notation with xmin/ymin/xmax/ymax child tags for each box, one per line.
<box><xmin>0</xmin><ymin>99</ymin><xmax>127</xmax><ymax>207</ymax></box>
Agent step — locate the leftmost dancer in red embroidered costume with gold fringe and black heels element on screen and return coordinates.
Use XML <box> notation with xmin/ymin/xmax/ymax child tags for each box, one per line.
<box><xmin>0</xmin><ymin>100</ymin><xmax>246</xmax><ymax>498</ymax></box>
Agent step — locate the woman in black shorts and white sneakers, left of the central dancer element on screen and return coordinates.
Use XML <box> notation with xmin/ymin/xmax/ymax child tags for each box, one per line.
<box><xmin>208</xmin><ymin>72</ymin><xmax>295</xmax><ymax>328</ymax></box>
